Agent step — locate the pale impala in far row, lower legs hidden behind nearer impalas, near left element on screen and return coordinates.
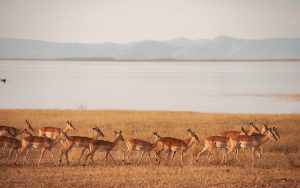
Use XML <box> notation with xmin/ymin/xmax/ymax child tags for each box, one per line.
<box><xmin>39</xmin><ymin>121</ymin><xmax>75</xmax><ymax>147</ymax></box>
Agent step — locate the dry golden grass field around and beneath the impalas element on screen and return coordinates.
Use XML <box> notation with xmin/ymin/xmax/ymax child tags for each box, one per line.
<box><xmin>0</xmin><ymin>110</ymin><xmax>300</xmax><ymax>187</ymax></box>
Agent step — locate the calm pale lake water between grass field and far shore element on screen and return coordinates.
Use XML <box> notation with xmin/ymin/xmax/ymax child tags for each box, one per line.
<box><xmin>0</xmin><ymin>60</ymin><xmax>300</xmax><ymax>113</ymax></box>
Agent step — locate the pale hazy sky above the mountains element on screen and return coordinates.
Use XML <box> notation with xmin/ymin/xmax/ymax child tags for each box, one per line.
<box><xmin>0</xmin><ymin>0</ymin><xmax>300</xmax><ymax>43</ymax></box>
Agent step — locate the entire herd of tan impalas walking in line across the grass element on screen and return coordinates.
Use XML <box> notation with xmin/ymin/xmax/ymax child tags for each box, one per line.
<box><xmin>0</xmin><ymin>120</ymin><xmax>280</xmax><ymax>167</ymax></box>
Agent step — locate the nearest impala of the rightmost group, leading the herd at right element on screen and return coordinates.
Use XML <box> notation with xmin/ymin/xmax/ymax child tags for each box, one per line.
<box><xmin>227</xmin><ymin>129</ymin><xmax>277</xmax><ymax>162</ymax></box>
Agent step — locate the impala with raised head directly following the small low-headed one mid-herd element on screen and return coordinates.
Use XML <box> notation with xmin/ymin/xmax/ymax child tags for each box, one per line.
<box><xmin>83</xmin><ymin>131</ymin><xmax>124</xmax><ymax>167</ymax></box>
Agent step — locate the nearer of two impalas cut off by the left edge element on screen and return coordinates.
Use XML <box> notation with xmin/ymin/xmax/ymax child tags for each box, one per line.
<box><xmin>0</xmin><ymin>130</ymin><xmax>30</xmax><ymax>163</ymax></box>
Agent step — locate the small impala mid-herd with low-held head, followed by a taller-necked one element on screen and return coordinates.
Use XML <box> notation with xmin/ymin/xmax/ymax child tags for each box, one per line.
<box><xmin>123</xmin><ymin>133</ymin><xmax>157</xmax><ymax>165</ymax></box>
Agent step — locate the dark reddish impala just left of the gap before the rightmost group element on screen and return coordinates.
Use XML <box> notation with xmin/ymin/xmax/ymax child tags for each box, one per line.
<box><xmin>154</xmin><ymin>132</ymin><xmax>199</xmax><ymax>167</ymax></box>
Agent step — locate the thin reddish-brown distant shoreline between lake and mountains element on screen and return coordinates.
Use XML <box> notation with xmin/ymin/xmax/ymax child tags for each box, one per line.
<box><xmin>0</xmin><ymin>58</ymin><xmax>300</xmax><ymax>62</ymax></box>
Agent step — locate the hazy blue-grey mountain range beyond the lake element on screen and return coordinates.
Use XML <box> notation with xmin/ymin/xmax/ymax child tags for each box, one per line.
<box><xmin>0</xmin><ymin>36</ymin><xmax>300</xmax><ymax>59</ymax></box>
